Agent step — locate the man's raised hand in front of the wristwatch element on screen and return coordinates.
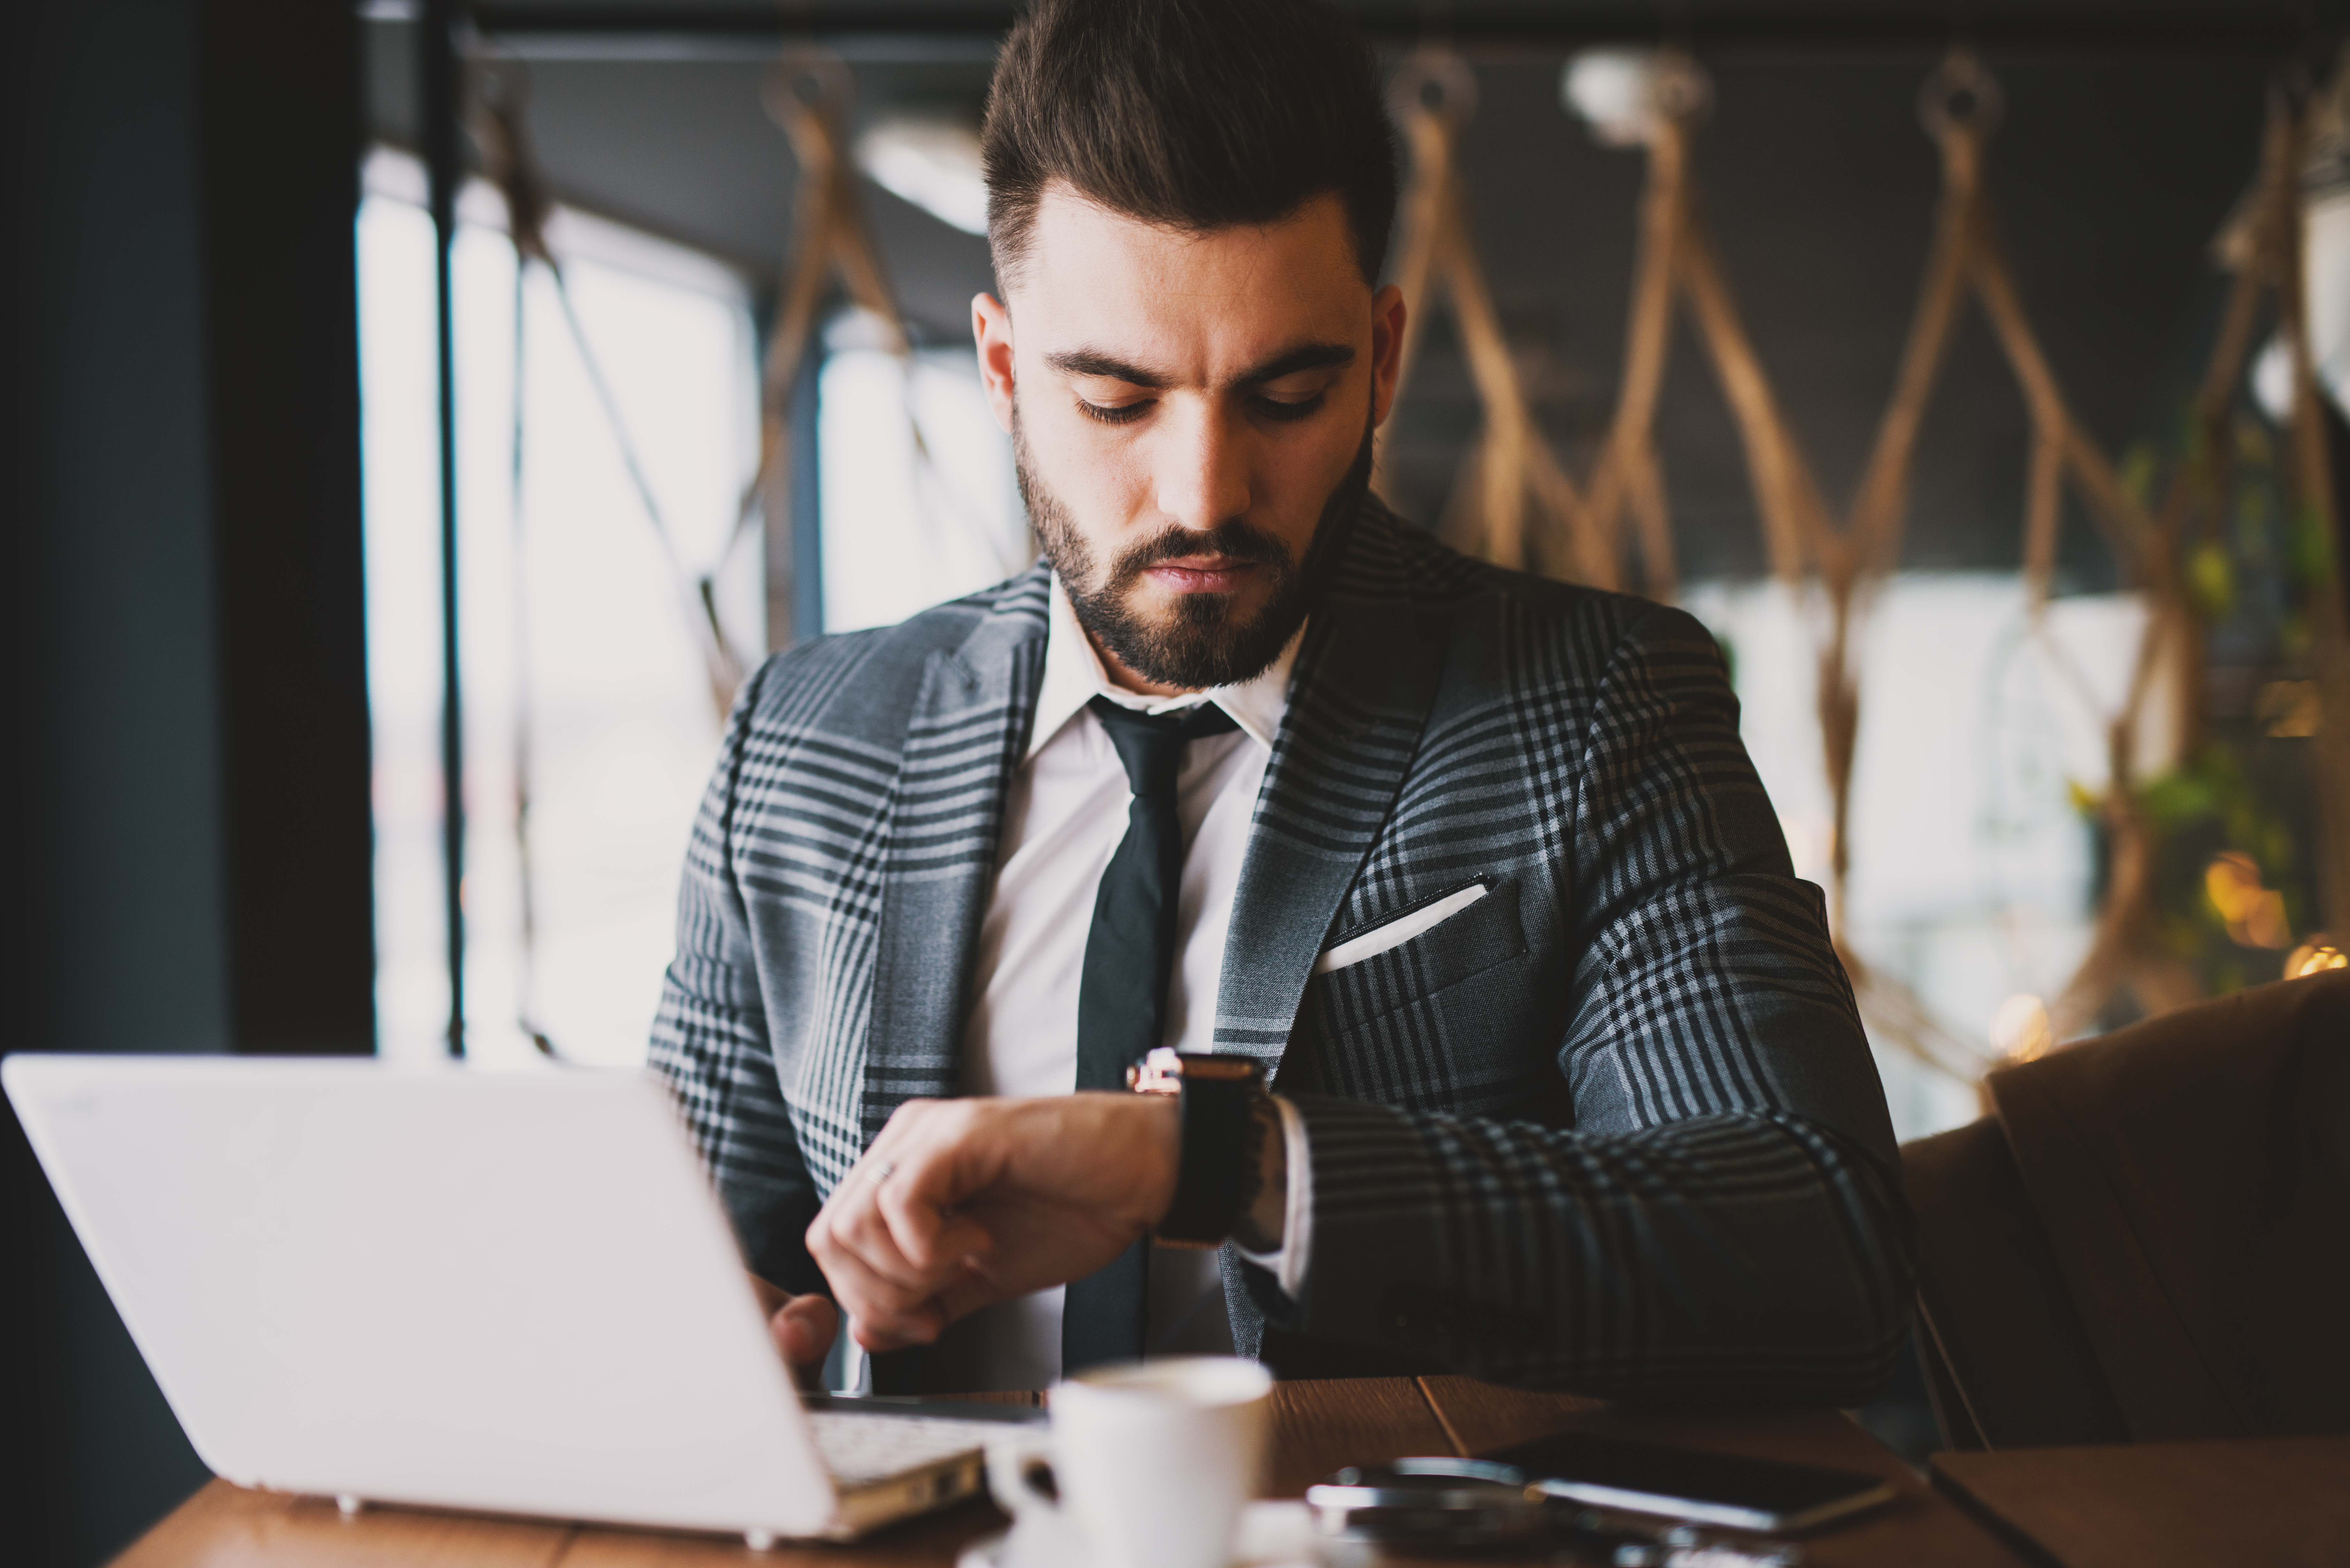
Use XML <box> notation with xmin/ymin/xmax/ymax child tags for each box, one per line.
<box><xmin>808</xmin><ymin>1093</ymin><xmax>1180</xmax><ymax>1349</ymax></box>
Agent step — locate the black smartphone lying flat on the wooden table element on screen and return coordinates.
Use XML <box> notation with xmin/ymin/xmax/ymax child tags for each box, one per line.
<box><xmin>1481</xmin><ymin>1434</ymin><xmax>1894</xmax><ymax>1530</ymax></box>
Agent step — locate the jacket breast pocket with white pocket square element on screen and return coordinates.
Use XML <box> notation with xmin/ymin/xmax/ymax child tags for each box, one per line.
<box><xmin>1311</xmin><ymin>877</ymin><xmax>1525</xmax><ymax>1034</ymax></box>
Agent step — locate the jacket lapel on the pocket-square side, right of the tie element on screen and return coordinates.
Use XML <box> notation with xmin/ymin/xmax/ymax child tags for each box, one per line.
<box><xmin>1215</xmin><ymin>503</ymin><xmax>1443</xmax><ymax>1074</ymax></box>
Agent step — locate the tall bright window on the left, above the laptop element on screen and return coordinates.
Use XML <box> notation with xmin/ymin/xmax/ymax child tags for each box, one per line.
<box><xmin>357</xmin><ymin>150</ymin><xmax>766</xmax><ymax>1063</ymax></box>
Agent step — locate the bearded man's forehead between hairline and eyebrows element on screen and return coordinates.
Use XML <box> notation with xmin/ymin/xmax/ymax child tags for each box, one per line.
<box><xmin>1006</xmin><ymin>183</ymin><xmax>1370</xmax><ymax>379</ymax></box>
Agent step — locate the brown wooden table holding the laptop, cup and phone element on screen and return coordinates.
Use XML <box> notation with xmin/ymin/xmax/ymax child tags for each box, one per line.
<box><xmin>118</xmin><ymin>1377</ymin><xmax>2023</xmax><ymax>1568</ymax></box>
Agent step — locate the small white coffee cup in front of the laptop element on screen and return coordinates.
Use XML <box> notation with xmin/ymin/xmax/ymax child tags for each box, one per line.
<box><xmin>987</xmin><ymin>1356</ymin><xmax>1274</xmax><ymax>1568</ymax></box>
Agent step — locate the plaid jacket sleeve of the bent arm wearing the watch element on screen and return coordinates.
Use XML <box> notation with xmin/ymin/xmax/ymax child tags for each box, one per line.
<box><xmin>1250</xmin><ymin>609</ymin><xmax>1915</xmax><ymax>1403</ymax></box>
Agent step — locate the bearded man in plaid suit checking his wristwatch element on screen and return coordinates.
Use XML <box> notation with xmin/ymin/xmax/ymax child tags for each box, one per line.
<box><xmin>653</xmin><ymin>0</ymin><xmax>1913</xmax><ymax>1403</ymax></box>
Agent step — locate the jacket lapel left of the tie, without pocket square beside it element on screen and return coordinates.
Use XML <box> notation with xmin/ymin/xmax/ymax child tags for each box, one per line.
<box><xmin>860</xmin><ymin>567</ymin><xmax>1048</xmax><ymax>1142</ymax></box>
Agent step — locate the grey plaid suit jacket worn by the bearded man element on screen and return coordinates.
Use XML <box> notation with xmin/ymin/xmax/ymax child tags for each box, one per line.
<box><xmin>651</xmin><ymin>501</ymin><xmax>1915</xmax><ymax>1403</ymax></box>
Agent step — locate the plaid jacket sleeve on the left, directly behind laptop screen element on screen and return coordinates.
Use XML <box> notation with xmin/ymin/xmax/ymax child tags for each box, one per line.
<box><xmin>646</xmin><ymin>660</ymin><xmax>825</xmax><ymax>1291</ymax></box>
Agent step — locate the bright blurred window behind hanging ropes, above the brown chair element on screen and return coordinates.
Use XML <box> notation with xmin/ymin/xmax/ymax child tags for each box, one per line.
<box><xmin>1683</xmin><ymin>571</ymin><xmax>2164</xmax><ymax>1138</ymax></box>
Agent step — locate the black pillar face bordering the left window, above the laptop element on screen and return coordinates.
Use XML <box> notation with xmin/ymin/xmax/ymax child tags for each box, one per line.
<box><xmin>197</xmin><ymin>0</ymin><xmax>376</xmax><ymax>1053</ymax></box>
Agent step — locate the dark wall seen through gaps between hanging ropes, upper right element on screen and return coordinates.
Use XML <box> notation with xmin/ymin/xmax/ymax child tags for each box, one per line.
<box><xmin>1389</xmin><ymin>49</ymin><xmax>2282</xmax><ymax>588</ymax></box>
